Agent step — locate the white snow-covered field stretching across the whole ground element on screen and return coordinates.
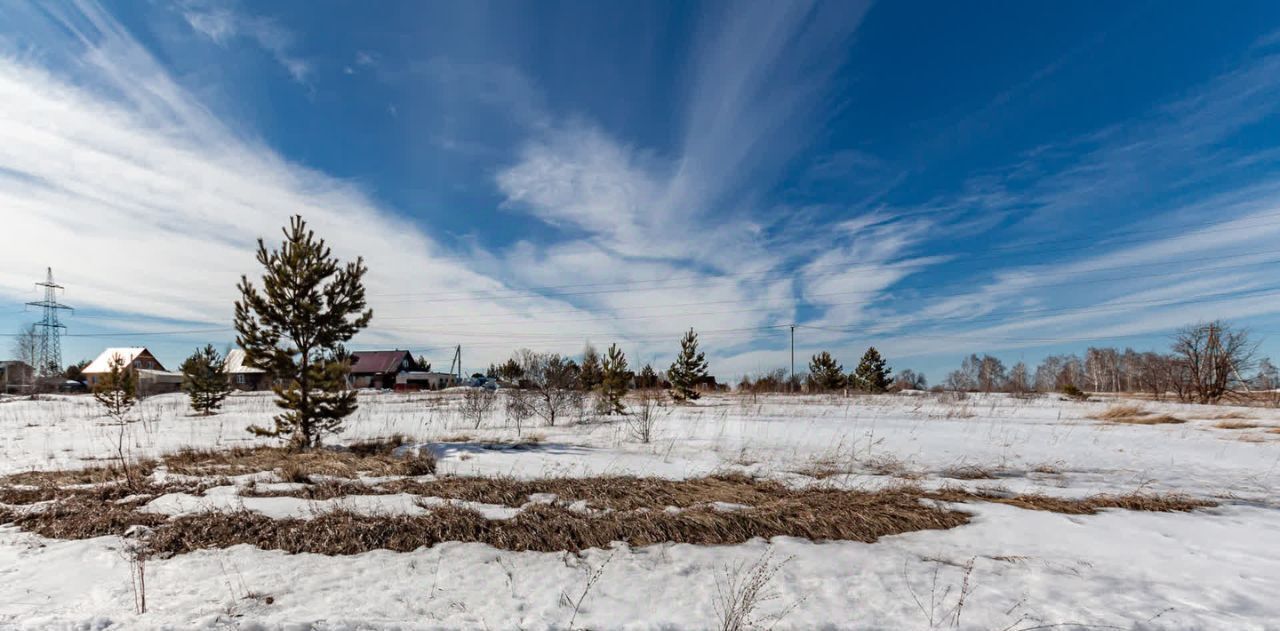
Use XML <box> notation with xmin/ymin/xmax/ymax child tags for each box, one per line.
<box><xmin>0</xmin><ymin>393</ymin><xmax>1280</xmax><ymax>630</ymax></box>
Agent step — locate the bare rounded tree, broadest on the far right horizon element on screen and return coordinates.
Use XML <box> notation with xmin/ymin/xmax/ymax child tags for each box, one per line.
<box><xmin>1172</xmin><ymin>321</ymin><xmax>1258</xmax><ymax>403</ymax></box>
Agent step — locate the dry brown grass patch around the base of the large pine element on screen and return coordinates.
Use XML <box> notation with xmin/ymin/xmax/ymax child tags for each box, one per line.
<box><xmin>161</xmin><ymin>436</ymin><xmax>435</xmax><ymax>483</ymax></box>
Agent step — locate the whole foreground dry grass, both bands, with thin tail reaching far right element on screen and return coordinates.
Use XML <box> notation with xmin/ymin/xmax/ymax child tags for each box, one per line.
<box><xmin>0</xmin><ymin>465</ymin><xmax>1212</xmax><ymax>554</ymax></box>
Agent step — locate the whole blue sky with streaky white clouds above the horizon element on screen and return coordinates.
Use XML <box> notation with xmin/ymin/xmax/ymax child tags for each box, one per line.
<box><xmin>0</xmin><ymin>1</ymin><xmax>1280</xmax><ymax>380</ymax></box>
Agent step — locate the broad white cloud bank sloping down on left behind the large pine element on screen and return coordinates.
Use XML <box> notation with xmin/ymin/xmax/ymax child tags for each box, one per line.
<box><xmin>0</xmin><ymin>1</ymin><xmax>616</xmax><ymax>361</ymax></box>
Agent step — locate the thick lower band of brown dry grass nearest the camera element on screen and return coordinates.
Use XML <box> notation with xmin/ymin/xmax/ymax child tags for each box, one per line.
<box><xmin>152</xmin><ymin>483</ymin><xmax>969</xmax><ymax>554</ymax></box>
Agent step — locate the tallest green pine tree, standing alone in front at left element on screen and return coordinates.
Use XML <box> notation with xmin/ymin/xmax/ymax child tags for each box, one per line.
<box><xmin>236</xmin><ymin>216</ymin><xmax>374</xmax><ymax>449</ymax></box>
